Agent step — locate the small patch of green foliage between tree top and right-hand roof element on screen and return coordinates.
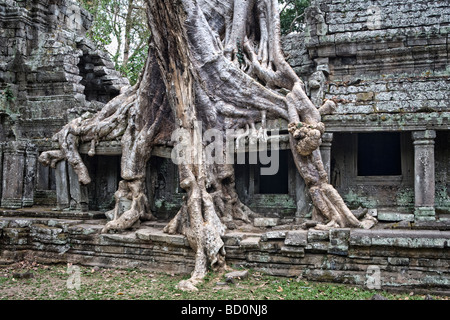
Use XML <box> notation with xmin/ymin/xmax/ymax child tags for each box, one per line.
<box><xmin>278</xmin><ymin>0</ymin><xmax>310</xmax><ymax>34</ymax></box>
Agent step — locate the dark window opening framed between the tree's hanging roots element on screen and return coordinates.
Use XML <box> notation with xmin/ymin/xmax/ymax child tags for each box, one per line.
<box><xmin>255</xmin><ymin>150</ymin><xmax>289</xmax><ymax>194</ymax></box>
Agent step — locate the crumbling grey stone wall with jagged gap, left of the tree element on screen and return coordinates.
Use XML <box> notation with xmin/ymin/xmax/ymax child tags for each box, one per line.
<box><xmin>0</xmin><ymin>0</ymin><xmax>129</xmax><ymax>208</ymax></box>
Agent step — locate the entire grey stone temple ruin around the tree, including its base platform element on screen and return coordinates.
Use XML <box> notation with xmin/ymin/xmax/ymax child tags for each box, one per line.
<box><xmin>0</xmin><ymin>0</ymin><xmax>450</xmax><ymax>293</ymax></box>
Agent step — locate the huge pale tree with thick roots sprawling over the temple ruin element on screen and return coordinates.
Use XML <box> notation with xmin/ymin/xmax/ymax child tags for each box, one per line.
<box><xmin>40</xmin><ymin>0</ymin><xmax>373</xmax><ymax>290</ymax></box>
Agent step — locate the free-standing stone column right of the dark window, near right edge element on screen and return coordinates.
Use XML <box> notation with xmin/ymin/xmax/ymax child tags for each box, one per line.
<box><xmin>412</xmin><ymin>130</ymin><xmax>436</xmax><ymax>221</ymax></box>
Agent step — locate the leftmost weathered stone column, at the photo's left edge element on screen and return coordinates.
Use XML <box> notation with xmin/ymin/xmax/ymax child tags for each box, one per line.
<box><xmin>1</xmin><ymin>141</ymin><xmax>26</xmax><ymax>209</ymax></box>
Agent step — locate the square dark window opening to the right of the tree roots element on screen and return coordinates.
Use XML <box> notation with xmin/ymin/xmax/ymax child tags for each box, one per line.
<box><xmin>358</xmin><ymin>132</ymin><xmax>402</xmax><ymax>176</ymax></box>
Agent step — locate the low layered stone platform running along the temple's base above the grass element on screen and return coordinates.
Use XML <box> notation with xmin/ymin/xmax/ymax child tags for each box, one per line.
<box><xmin>0</xmin><ymin>212</ymin><xmax>450</xmax><ymax>294</ymax></box>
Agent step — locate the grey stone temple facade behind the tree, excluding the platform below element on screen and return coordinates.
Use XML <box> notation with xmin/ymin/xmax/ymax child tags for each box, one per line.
<box><xmin>0</xmin><ymin>0</ymin><xmax>450</xmax><ymax>226</ymax></box>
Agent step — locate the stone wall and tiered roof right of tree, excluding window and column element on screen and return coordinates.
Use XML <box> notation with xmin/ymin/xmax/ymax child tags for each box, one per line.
<box><xmin>283</xmin><ymin>0</ymin><xmax>450</xmax><ymax>220</ymax></box>
